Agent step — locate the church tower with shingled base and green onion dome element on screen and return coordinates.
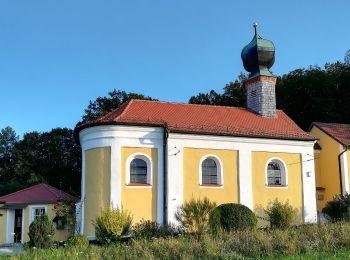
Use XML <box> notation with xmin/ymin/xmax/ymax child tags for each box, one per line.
<box><xmin>241</xmin><ymin>23</ymin><xmax>276</xmax><ymax>118</ymax></box>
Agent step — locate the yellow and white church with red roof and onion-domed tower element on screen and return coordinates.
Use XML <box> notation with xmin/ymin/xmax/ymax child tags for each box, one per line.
<box><xmin>76</xmin><ymin>27</ymin><xmax>317</xmax><ymax>239</ymax></box>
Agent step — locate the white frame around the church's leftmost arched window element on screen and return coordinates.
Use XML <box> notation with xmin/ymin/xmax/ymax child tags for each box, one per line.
<box><xmin>125</xmin><ymin>153</ymin><xmax>153</xmax><ymax>188</ymax></box>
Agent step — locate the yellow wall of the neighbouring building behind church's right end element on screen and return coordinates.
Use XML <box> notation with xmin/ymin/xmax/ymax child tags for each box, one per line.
<box><xmin>310</xmin><ymin>127</ymin><xmax>340</xmax><ymax>212</ymax></box>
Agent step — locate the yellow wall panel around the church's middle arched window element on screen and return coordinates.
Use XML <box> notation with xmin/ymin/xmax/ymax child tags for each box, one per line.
<box><xmin>183</xmin><ymin>148</ymin><xmax>239</xmax><ymax>205</ymax></box>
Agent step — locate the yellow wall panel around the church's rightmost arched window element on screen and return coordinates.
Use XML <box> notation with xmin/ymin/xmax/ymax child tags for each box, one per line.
<box><xmin>252</xmin><ymin>152</ymin><xmax>303</xmax><ymax>223</ymax></box>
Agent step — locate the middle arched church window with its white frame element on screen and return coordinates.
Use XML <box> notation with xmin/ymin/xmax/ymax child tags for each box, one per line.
<box><xmin>200</xmin><ymin>155</ymin><xmax>223</xmax><ymax>186</ymax></box>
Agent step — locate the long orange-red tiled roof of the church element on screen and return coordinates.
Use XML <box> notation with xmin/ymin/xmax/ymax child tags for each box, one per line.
<box><xmin>76</xmin><ymin>100</ymin><xmax>314</xmax><ymax>140</ymax></box>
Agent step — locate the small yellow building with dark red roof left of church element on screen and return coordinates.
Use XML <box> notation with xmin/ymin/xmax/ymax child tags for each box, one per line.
<box><xmin>0</xmin><ymin>183</ymin><xmax>78</xmax><ymax>244</ymax></box>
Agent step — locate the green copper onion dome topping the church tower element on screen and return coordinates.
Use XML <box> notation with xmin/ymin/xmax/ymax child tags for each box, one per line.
<box><xmin>241</xmin><ymin>23</ymin><xmax>275</xmax><ymax>79</ymax></box>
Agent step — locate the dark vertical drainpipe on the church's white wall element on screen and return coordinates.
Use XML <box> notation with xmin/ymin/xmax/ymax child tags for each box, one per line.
<box><xmin>163</xmin><ymin>126</ymin><xmax>169</xmax><ymax>225</ymax></box>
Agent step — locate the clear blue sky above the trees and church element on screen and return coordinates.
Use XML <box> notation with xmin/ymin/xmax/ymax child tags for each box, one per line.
<box><xmin>0</xmin><ymin>0</ymin><xmax>350</xmax><ymax>135</ymax></box>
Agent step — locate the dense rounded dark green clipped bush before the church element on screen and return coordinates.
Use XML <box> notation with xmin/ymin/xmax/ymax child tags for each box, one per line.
<box><xmin>210</xmin><ymin>203</ymin><xmax>258</xmax><ymax>231</ymax></box>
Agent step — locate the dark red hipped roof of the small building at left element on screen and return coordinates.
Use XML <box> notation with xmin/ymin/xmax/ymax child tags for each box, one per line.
<box><xmin>0</xmin><ymin>183</ymin><xmax>78</xmax><ymax>204</ymax></box>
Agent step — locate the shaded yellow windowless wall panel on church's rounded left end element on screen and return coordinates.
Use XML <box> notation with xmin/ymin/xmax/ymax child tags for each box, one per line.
<box><xmin>83</xmin><ymin>147</ymin><xmax>110</xmax><ymax>236</ymax></box>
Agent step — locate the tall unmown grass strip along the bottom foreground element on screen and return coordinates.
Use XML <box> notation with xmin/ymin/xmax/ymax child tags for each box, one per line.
<box><xmin>5</xmin><ymin>223</ymin><xmax>350</xmax><ymax>260</ymax></box>
